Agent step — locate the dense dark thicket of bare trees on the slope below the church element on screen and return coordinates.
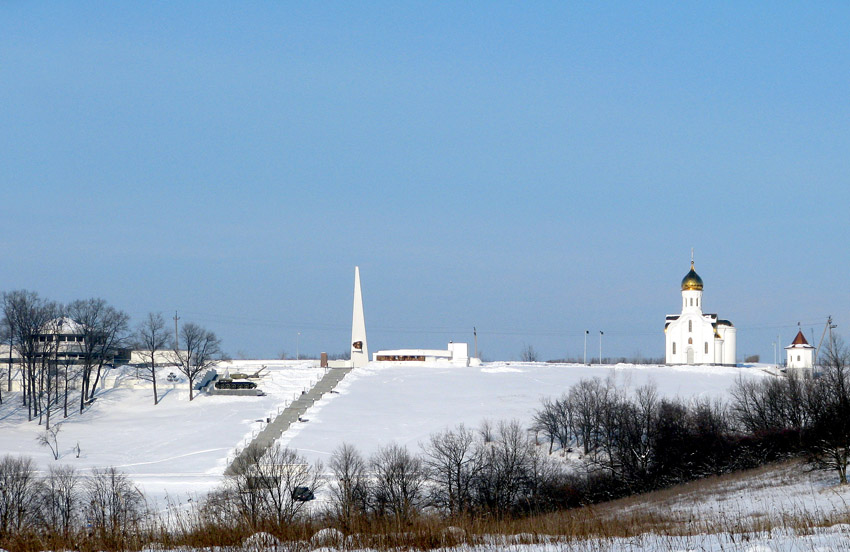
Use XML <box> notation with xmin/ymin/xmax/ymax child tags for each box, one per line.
<box><xmin>534</xmin><ymin>336</ymin><xmax>850</xmax><ymax>500</ymax></box>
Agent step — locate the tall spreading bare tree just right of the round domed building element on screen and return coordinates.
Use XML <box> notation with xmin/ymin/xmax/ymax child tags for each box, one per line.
<box><xmin>67</xmin><ymin>299</ymin><xmax>130</xmax><ymax>412</ymax></box>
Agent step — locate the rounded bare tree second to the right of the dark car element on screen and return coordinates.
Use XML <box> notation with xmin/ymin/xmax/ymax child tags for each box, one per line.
<box><xmin>370</xmin><ymin>443</ymin><xmax>426</xmax><ymax>521</ymax></box>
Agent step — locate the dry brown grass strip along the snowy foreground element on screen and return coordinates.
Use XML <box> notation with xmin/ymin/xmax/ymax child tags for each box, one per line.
<box><xmin>2</xmin><ymin>461</ymin><xmax>850</xmax><ymax>552</ymax></box>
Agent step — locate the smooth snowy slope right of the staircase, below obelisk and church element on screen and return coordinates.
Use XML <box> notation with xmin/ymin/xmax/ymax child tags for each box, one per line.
<box><xmin>281</xmin><ymin>362</ymin><xmax>769</xmax><ymax>462</ymax></box>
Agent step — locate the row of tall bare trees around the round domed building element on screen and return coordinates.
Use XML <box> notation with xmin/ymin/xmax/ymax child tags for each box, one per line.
<box><xmin>0</xmin><ymin>290</ymin><xmax>222</xmax><ymax>429</ymax></box>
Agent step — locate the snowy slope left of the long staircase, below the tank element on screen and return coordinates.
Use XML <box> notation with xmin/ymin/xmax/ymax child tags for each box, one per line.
<box><xmin>0</xmin><ymin>361</ymin><xmax>324</xmax><ymax>501</ymax></box>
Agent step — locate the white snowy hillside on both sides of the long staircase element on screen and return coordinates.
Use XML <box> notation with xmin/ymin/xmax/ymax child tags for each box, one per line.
<box><xmin>0</xmin><ymin>361</ymin><xmax>770</xmax><ymax>501</ymax></box>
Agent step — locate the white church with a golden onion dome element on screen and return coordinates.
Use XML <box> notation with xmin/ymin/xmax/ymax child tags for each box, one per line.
<box><xmin>664</xmin><ymin>261</ymin><xmax>737</xmax><ymax>366</ymax></box>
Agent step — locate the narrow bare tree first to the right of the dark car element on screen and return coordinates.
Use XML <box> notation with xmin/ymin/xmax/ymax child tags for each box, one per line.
<box><xmin>328</xmin><ymin>443</ymin><xmax>370</xmax><ymax>530</ymax></box>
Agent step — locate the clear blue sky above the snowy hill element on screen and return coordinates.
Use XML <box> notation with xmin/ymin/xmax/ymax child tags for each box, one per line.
<box><xmin>0</xmin><ymin>2</ymin><xmax>850</xmax><ymax>362</ymax></box>
